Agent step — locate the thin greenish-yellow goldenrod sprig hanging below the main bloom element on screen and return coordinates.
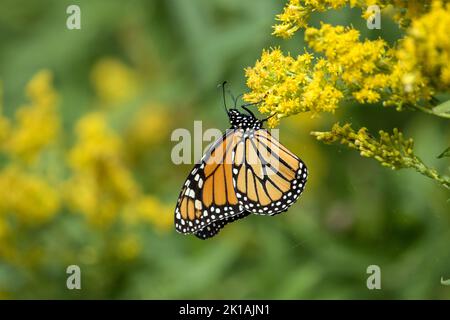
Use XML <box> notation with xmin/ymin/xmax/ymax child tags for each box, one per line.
<box><xmin>311</xmin><ymin>123</ymin><xmax>450</xmax><ymax>189</ymax></box>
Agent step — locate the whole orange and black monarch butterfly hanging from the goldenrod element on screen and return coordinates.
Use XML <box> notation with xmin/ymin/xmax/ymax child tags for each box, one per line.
<box><xmin>175</xmin><ymin>82</ymin><xmax>308</xmax><ymax>239</ymax></box>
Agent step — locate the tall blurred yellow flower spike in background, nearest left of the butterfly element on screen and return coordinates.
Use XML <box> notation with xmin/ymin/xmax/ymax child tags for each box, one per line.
<box><xmin>66</xmin><ymin>112</ymin><xmax>139</xmax><ymax>226</ymax></box>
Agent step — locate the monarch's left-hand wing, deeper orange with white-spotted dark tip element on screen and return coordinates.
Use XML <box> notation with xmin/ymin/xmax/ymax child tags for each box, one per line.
<box><xmin>175</xmin><ymin>130</ymin><xmax>243</xmax><ymax>238</ymax></box>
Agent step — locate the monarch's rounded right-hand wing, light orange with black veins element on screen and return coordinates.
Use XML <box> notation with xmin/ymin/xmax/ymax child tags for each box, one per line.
<box><xmin>233</xmin><ymin>129</ymin><xmax>308</xmax><ymax>215</ymax></box>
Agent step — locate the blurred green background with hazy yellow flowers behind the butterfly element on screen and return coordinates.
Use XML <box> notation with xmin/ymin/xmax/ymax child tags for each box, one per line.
<box><xmin>0</xmin><ymin>0</ymin><xmax>450</xmax><ymax>299</ymax></box>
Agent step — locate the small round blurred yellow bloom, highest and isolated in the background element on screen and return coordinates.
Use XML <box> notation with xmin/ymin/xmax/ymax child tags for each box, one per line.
<box><xmin>91</xmin><ymin>58</ymin><xmax>138</xmax><ymax>106</ymax></box>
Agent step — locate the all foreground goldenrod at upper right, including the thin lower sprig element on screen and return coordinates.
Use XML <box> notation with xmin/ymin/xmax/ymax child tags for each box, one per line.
<box><xmin>244</xmin><ymin>0</ymin><xmax>450</xmax><ymax>187</ymax></box>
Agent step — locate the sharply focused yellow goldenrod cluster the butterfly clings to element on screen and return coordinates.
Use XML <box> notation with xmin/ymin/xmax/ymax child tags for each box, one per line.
<box><xmin>244</xmin><ymin>24</ymin><xmax>391</xmax><ymax>125</ymax></box>
